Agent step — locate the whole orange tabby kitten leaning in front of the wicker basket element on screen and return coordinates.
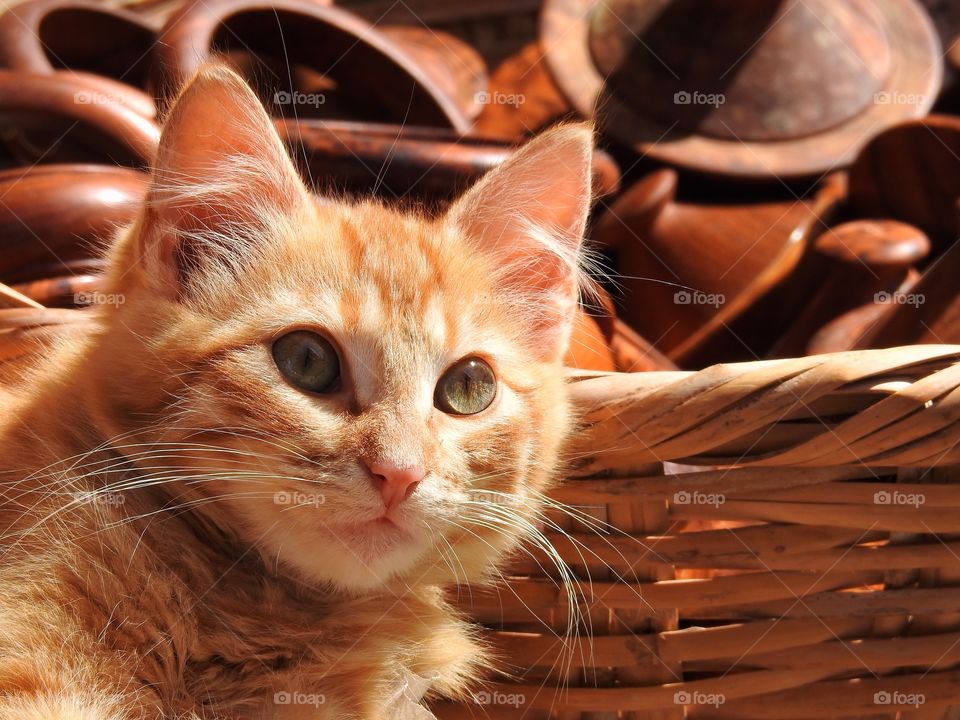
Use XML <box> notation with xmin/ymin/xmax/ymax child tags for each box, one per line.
<box><xmin>0</xmin><ymin>67</ymin><xmax>591</xmax><ymax>720</ymax></box>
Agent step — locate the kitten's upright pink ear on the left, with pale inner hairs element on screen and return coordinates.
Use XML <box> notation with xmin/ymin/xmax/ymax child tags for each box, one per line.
<box><xmin>138</xmin><ymin>65</ymin><xmax>310</xmax><ymax>297</ymax></box>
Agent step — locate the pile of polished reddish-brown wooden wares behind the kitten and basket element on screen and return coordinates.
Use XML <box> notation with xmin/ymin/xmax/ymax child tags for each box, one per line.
<box><xmin>0</xmin><ymin>0</ymin><xmax>960</xmax><ymax>371</ymax></box>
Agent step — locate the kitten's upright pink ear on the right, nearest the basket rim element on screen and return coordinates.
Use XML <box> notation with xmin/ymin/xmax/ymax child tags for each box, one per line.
<box><xmin>448</xmin><ymin>124</ymin><xmax>593</xmax><ymax>360</ymax></box>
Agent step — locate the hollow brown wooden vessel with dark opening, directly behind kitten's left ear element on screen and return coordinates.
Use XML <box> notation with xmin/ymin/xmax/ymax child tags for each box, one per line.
<box><xmin>153</xmin><ymin>0</ymin><xmax>485</xmax><ymax>132</ymax></box>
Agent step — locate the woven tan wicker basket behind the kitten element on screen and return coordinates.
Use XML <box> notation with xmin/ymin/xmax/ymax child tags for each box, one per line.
<box><xmin>0</xmin><ymin>308</ymin><xmax>960</xmax><ymax>720</ymax></box>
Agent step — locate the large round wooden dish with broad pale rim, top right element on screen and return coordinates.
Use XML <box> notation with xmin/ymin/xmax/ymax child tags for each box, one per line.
<box><xmin>541</xmin><ymin>0</ymin><xmax>942</xmax><ymax>179</ymax></box>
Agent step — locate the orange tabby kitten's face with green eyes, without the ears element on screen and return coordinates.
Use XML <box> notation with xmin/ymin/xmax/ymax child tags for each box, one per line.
<box><xmin>106</xmin><ymin>206</ymin><xmax>566</xmax><ymax>585</ymax></box>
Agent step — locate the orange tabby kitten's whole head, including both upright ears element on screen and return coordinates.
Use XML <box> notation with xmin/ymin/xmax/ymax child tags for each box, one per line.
<box><xmin>95</xmin><ymin>70</ymin><xmax>589</xmax><ymax>590</ymax></box>
